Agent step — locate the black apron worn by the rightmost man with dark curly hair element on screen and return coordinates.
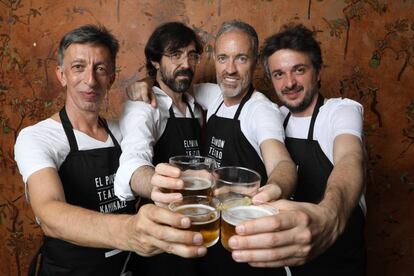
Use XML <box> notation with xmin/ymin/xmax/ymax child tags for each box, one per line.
<box><xmin>283</xmin><ymin>95</ymin><xmax>366</xmax><ymax>276</ymax></box>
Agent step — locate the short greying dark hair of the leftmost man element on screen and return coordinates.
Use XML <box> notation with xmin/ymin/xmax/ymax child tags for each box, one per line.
<box><xmin>58</xmin><ymin>24</ymin><xmax>119</xmax><ymax>69</ymax></box>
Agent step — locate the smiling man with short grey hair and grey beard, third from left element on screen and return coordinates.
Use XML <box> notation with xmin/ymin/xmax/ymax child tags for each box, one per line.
<box><xmin>129</xmin><ymin>21</ymin><xmax>296</xmax><ymax>276</ymax></box>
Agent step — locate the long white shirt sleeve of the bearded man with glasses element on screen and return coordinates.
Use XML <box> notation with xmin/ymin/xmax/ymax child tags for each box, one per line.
<box><xmin>114</xmin><ymin>101</ymin><xmax>158</xmax><ymax>200</ymax></box>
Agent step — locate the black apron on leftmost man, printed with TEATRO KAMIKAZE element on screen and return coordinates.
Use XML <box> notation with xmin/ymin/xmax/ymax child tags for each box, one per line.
<box><xmin>31</xmin><ymin>108</ymin><xmax>135</xmax><ymax>276</ymax></box>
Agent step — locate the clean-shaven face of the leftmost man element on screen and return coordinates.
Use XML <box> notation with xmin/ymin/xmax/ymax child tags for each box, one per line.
<box><xmin>56</xmin><ymin>43</ymin><xmax>115</xmax><ymax>112</ymax></box>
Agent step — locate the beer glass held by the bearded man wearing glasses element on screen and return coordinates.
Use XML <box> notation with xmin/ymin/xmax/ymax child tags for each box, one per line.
<box><xmin>168</xmin><ymin>155</ymin><xmax>216</xmax><ymax>196</ymax></box>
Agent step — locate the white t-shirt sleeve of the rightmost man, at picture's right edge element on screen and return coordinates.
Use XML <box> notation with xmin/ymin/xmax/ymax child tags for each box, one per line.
<box><xmin>330</xmin><ymin>99</ymin><xmax>363</xmax><ymax>139</ymax></box>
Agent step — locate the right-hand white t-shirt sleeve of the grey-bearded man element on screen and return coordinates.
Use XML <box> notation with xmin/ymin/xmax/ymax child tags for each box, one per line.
<box><xmin>246</xmin><ymin>96</ymin><xmax>285</xmax><ymax>145</ymax></box>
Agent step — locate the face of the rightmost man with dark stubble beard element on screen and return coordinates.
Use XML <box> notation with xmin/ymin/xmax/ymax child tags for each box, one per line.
<box><xmin>268</xmin><ymin>49</ymin><xmax>320</xmax><ymax>116</ymax></box>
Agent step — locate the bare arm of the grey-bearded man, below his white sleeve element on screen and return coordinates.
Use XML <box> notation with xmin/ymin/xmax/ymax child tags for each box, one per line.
<box><xmin>253</xmin><ymin>139</ymin><xmax>297</xmax><ymax>202</ymax></box>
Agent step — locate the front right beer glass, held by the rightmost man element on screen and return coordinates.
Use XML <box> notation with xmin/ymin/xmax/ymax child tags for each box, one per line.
<box><xmin>220</xmin><ymin>201</ymin><xmax>277</xmax><ymax>251</ymax></box>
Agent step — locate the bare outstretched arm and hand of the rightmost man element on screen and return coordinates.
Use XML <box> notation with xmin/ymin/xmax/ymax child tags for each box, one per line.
<box><xmin>230</xmin><ymin>134</ymin><xmax>363</xmax><ymax>266</ymax></box>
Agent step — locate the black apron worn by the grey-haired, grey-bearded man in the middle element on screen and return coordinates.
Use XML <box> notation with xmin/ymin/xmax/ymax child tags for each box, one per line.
<box><xmin>197</xmin><ymin>87</ymin><xmax>286</xmax><ymax>276</ymax></box>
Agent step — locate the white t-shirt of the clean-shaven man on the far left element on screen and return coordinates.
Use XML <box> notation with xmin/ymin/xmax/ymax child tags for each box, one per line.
<box><xmin>14</xmin><ymin>118</ymin><xmax>122</xmax><ymax>183</ymax></box>
